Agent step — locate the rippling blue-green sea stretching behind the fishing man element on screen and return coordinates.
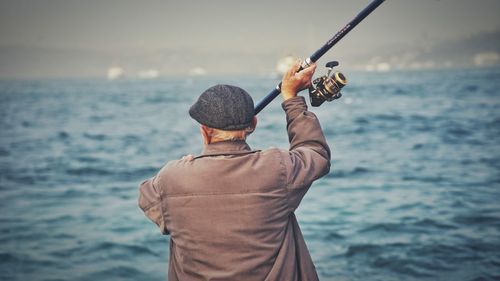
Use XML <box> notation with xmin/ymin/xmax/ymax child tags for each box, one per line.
<box><xmin>0</xmin><ymin>68</ymin><xmax>500</xmax><ymax>281</ymax></box>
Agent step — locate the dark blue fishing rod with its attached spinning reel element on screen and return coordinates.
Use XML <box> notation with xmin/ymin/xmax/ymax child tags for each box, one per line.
<box><xmin>254</xmin><ymin>0</ymin><xmax>385</xmax><ymax>115</ymax></box>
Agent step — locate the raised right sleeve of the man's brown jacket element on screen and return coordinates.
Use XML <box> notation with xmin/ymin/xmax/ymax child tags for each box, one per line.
<box><xmin>282</xmin><ymin>96</ymin><xmax>330</xmax><ymax>210</ymax></box>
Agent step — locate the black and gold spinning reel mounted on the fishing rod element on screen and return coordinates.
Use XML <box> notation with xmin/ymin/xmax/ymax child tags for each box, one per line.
<box><xmin>309</xmin><ymin>61</ymin><xmax>347</xmax><ymax>107</ymax></box>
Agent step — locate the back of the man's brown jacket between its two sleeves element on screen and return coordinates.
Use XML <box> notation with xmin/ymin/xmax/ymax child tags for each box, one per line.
<box><xmin>162</xmin><ymin>142</ymin><xmax>306</xmax><ymax>280</ymax></box>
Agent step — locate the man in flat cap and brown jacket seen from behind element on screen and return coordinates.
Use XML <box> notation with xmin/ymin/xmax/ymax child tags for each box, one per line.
<box><xmin>139</xmin><ymin>61</ymin><xmax>330</xmax><ymax>281</ymax></box>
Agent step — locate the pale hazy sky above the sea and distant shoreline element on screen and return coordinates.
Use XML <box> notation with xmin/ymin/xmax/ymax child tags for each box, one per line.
<box><xmin>0</xmin><ymin>0</ymin><xmax>500</xmax><ymax>77</ymax></box>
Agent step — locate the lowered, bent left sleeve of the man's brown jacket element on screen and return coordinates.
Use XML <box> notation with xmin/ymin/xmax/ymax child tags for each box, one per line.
<box><xmin>139</xmin><ymin>178</ymin><xmax>169</xmax><ymax>235</ymax></box>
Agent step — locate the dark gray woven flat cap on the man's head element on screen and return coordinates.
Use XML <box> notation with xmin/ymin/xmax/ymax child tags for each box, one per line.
<box><xmin>189</xmin><ymin>85</ymin><xmax>254</xmax><ymax>131</ymax></box>
